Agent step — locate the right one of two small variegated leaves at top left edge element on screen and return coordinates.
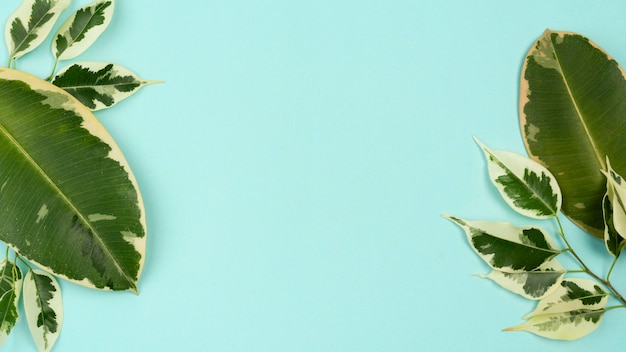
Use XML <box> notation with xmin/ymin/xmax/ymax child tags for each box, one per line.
<box><xmin>52</xmin><ymin>0</ymin><xmax>115</xmax><ymax>60</ymax></box>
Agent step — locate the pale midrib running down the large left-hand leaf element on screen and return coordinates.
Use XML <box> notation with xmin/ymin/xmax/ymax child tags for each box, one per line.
<box><xmin>0</xmin><ymin>125</ymin><xmax>136</xmax><ymax>289</ymax></box>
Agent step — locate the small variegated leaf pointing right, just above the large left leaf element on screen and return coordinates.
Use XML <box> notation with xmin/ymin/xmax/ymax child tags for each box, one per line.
<box><xmin>52</xmin><ymin>62</ymin><xmax>158</xmax><ymax>111</ymax></box>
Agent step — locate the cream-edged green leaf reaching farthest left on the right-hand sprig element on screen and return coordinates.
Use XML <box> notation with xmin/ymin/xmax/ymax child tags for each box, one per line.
<box><xmin>444</xmin><ymin>215</ymin><xmax>561</xmax><ymax>273</ymax></box>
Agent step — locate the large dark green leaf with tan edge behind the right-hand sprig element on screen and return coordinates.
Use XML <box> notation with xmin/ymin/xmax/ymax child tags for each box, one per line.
<box><xmin>520</xmin><ymin>30</ymin><xmax>626</xmax><ymax>238</ymax></box>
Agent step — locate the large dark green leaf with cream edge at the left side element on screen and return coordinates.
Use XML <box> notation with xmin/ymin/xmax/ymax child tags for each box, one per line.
<box><xmin>0</xmin><ymin>69</ymin><xmax>146</xmax><ymax>292</ymax></box>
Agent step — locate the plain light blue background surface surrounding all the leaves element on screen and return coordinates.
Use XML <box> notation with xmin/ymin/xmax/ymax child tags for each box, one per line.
<box><xmin>0</xmin><ymin>0</ymin><xmax>626</xmax><ymax>352</ymax></box>
